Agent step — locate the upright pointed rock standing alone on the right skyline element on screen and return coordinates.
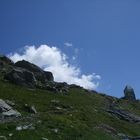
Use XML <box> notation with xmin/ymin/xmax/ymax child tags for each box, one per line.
<box><xmin>124</xmin><ymin>86</ymin><xmax>136</xmax><ymax>101</ymax></box>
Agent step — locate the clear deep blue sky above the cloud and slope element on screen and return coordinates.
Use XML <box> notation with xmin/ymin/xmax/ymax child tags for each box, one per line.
<box><xmin>0</xmin><ymin>0</ymin><xmax>140</xmax><ymax>98</ymax></box>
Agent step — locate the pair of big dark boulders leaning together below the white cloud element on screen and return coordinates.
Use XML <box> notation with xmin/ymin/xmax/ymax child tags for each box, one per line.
<box><xmin>5</xmin><ymin>60</ymin><xmax>54</xmax><ymax>88</ymax></box>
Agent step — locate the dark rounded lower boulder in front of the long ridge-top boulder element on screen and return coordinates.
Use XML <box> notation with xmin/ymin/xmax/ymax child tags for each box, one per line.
<box><xmin>4</xmin><ymin>68</ymin><xmax>36</xmax><ymax>88</ymax></box>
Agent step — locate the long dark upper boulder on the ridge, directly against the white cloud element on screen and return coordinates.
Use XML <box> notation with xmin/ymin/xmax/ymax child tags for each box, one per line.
<box><xmin>15</xmin><ymin>60</ymin><xmax>54</xmax><ymax>83</ymax></box>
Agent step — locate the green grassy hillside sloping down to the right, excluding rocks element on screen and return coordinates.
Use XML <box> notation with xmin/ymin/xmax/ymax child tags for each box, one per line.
<box><xmin>0</xmin><ymin>81</ymin><xmax>140</xmax><ymax>140</ymax></box>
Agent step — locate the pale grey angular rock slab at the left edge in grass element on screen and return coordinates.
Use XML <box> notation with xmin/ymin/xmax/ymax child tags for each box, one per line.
<box><xmin>0</xmin><ymin>99</ymin><xmax>21</xmax><ymax>120</ymax></box>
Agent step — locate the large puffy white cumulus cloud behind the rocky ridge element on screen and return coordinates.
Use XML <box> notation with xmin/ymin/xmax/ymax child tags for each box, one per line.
<box><xmin>9</xmin><ymin>45</ymin><xmax>101</xmax><ymax>89</ymax></box>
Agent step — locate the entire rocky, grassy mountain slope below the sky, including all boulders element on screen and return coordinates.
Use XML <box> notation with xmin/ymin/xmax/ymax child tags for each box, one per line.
<box><xmin>0</xmin><ymin>55</ymin><xmax>140</xmax><ymax>140</ymax></box>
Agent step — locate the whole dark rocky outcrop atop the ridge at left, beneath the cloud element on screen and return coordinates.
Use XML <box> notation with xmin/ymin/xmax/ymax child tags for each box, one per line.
<box><xmin>0</xmin><ymin>55</ymin><xmax>69</xmax><ymax>93</ymax></box>
